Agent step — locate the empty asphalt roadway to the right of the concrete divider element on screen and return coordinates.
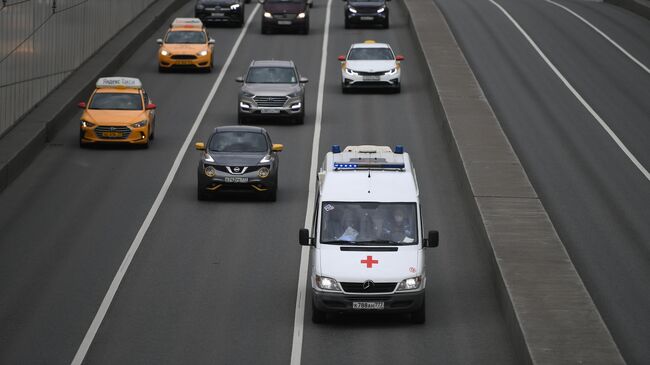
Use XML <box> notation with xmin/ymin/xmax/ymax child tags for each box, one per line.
<box><xmin>436</xmin><ymin>0</ymin><xmax>650</xmax><ymax>364</ymax></box>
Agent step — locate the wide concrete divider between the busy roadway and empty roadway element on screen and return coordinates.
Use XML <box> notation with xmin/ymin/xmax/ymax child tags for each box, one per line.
<box><xmin>402</xmin><ymin>0</ymin><xmax>625</xmax><ymax>364</ymax></box>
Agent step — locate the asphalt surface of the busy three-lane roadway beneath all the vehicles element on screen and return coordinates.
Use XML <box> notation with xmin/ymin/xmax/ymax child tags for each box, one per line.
<box><xmin>0</xmin><ymin>1</ymin><xmax>519</xmax><ymax>364</ymax></box>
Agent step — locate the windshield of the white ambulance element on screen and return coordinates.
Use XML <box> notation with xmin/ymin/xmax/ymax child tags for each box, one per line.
<box><xmin>320</xmin><ymin>202</ymin><xmax>418</xmax><ymax>245</ymax></box>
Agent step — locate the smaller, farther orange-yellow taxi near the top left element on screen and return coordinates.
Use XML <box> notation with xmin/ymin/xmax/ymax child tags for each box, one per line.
<box><xmin>157</xmin><ymin>18</ymin><xmax>214</xmax><ymax>72</ymax></box>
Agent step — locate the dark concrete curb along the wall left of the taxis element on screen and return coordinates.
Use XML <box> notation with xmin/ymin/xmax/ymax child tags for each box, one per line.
<box><xmin>0</xmin><ymin>0</ymin><xmax>188</xmax><ymax>193</ymax></box>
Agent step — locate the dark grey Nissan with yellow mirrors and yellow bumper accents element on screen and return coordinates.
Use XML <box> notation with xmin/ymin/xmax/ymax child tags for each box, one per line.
<box><xmin>195</xmin><ymin>126</ymin><xmax>283</xmax><ymax>201</ymax></box>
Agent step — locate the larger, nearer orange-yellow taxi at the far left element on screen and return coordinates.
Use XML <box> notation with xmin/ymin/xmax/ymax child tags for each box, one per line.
<box><xmin>78</xmin><ymin>76</ymin><xmax>156</xmax><ymax>148</ymax></box>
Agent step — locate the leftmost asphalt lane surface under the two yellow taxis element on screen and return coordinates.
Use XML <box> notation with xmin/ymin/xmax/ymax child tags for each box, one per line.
<box><xmin>0</xmin><ymin>2</ymin><xmax>246</xmax><ymax>364</ymax></box>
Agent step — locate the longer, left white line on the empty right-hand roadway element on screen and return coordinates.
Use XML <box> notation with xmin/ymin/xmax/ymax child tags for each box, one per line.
<box><xmin>490</xmin><ymin>0</ymin><xmax>650</xmax><ymax>181</ymax></box>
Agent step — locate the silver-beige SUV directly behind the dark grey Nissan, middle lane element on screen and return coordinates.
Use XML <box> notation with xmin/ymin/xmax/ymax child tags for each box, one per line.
<box><xmin>236</xmin><ymin>60</ymin><xmax>308</xmax><ymax>124</ymax></box>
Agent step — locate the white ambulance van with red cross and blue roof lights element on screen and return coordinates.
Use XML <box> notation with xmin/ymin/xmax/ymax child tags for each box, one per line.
<box><xmin>299</xmin><ymin>145</ymin><xmax>438</xmax><ymax>323</ymax></box>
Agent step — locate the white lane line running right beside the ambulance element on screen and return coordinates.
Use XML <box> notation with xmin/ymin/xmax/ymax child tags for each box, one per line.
<box><xmin>291</xmin><ymin>0</ymin><xmax>332</xmax><ymax>365</ymax></box>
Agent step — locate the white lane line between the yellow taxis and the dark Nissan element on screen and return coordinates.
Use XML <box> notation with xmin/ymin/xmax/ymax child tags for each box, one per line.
<box><xmin>71</xmin><ymin>4</ymin><xmax>260</xmax><ymax>365</ymax></box>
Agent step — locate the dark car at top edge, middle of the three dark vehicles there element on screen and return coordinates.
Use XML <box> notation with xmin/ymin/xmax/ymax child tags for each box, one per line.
<box><xmin>258</xmin><ymin>0</ymin><xmax>310</xmax><ymax>34</ymax></box>
